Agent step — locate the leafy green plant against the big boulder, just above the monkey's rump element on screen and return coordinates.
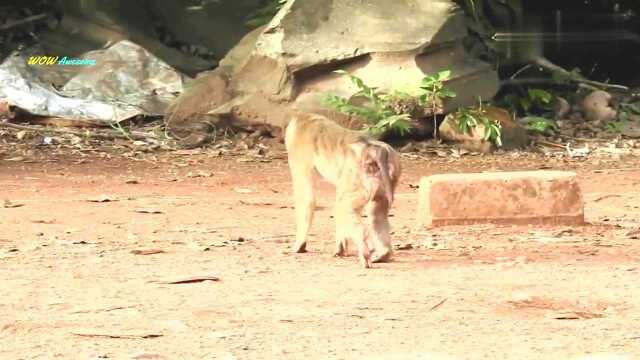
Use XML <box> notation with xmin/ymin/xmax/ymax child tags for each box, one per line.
<box><xmin>322</xmin><ymin>70</ymin><xmax>411</xmax><ymax>136</ymax></box>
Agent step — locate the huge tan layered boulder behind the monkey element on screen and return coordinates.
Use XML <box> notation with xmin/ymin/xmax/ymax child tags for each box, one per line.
<box><xmin>168</xmin><ymin>0</ymin><xmax>498</xmax><ymax>146</ymax></box>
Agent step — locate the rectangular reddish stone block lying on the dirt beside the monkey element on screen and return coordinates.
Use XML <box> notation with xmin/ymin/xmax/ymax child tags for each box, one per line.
<box><xmin>418</xmin><ymin>171</ymin><xmax>584</xmax><ymax>227</ymax></box>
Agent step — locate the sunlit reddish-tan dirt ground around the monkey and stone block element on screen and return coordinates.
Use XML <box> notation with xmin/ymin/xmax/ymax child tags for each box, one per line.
<box><xmin>0</xmin><ymin>147</ymin><xmax>640</xmax><ymax>359</ymax></box>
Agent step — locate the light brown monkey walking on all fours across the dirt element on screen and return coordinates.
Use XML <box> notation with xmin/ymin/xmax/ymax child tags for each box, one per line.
<box><xmin>285</xmin><ymin>114</ymin><xmax>401</xmax><ymax>268</ymax></box>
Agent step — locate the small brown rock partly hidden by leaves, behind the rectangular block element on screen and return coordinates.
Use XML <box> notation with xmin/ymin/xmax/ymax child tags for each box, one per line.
<box><xmin>438</xmin><ymin>106</ymin><xmax>529</xmax><ymax>153</ymax></box>
